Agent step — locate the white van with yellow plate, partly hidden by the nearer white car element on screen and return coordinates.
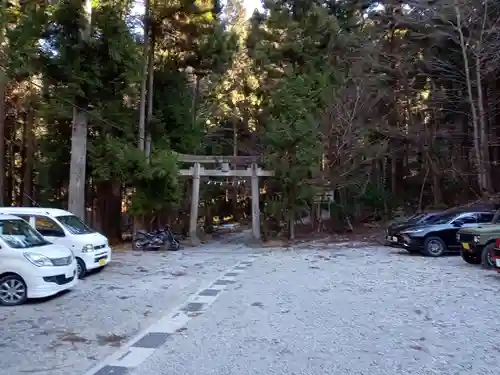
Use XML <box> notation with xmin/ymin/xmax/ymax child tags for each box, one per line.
<box><xmin>0</xmin><ymin>207</ymin><xmax>111</xmax><ymax>279</ymax></box>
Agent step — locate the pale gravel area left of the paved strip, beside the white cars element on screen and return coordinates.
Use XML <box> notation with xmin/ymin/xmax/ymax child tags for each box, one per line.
<box><xmin>0</xmin><ymin>244</ymin><xmax>249</xmax><ymax>375</ymax></box>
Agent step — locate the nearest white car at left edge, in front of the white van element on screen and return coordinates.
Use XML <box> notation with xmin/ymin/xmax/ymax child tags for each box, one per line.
<box><xmin>0</xmin><ymin>215</ymin><xmax>78</xmax><ymax>306</ymax></box>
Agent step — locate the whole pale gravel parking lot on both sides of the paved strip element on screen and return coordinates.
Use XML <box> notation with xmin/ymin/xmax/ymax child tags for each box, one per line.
<box><xmin>0</xmin><ymin>245</ymin><xmax>500</xmax><ymax>375</ymax></box>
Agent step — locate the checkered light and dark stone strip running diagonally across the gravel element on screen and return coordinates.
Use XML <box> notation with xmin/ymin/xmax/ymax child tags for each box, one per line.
<box><xmin>85</xmin><ymin>254</ymin><xmax>260</xmax><ymax>375</ymax></box>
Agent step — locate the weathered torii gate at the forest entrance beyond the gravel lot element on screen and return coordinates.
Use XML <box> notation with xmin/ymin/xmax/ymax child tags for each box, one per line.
<box><xmin>178</xmin><ymin>155</ymin><xmax>274</xmax><ymax>246</ymax></box>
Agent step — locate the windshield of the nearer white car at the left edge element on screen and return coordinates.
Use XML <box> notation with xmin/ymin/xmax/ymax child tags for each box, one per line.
<box><xmin>0</xmin><ymin>219</ymin><xmax>50</xmax><ymax>249</ymax></box>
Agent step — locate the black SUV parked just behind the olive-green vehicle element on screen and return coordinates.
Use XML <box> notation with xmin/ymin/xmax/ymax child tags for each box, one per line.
<box><xmin>394</xmin><ymin>211</ymin><xmax>494</xmax><ymax>257</ymax></box>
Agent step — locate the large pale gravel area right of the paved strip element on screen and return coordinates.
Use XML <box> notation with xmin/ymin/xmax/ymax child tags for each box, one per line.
<box><xmin>127</xmin><ymin>246</ymin><xmax>500</xmax><ymax>375</ymax></box>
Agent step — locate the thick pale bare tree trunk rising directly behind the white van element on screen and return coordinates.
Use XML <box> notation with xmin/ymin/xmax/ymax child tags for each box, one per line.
<box><xmin>68</xmin><ymin>0</ymin><xmax>92</xmax><ymax>220</ymax></box>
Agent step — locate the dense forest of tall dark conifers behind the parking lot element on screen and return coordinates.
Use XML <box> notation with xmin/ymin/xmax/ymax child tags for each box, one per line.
<box><xmin>0</xmin><ymin>0</ymin><xmax>500</xmax><ymax>239</ymax></box>
